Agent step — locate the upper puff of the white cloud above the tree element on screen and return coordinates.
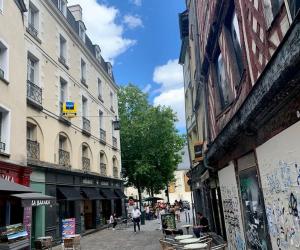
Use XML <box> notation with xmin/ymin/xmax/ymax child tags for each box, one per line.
<box><xmin>153</xmin><ymin>59</ymin><xmax>183</xmax><ymax>90</ymax></box>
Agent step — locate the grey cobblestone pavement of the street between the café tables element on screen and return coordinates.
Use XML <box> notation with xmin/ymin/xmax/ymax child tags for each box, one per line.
<box><xmin>53</xmin><ymin>210</ymin><xmax>192</xmax><ymax>250</ymax></box>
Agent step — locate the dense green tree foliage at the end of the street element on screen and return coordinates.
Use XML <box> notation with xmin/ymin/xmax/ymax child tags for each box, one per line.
<box><xmin>118</xmin><ymin>85</ymin><xmax>184</xmax><ymax>198</ymax></box>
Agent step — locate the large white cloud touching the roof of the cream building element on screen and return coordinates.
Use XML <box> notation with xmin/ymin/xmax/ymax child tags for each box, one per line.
<box><xmin>68</xmin><ymin>0</ymin><xmax>136</xmax><ymax>63</ymax></box>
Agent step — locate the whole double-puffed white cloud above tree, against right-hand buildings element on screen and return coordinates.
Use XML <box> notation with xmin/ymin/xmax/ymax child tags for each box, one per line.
<box><xmin>153</xmin><ymin>59</ymin><xmax>185</xmax><ymax>129</ymax></box>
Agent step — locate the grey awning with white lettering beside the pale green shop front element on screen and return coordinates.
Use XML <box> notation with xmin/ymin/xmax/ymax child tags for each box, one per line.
<box><xmin>11</xmin><ymin>193</ymin><xmax>56</xmax><ymax>207</ymax></box>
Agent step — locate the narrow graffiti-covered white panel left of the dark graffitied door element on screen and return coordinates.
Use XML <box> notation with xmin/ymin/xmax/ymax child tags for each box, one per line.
<box><xmin>218</xmin><ymin>163</ymin><xmax>246</xmax><ymax>250</ymax></box>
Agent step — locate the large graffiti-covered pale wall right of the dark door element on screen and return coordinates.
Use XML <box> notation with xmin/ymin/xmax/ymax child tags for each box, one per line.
<box><xmin>256</xmin><ymin>122</ymin><xmax>300</xmax><ymax>249</ymax></box>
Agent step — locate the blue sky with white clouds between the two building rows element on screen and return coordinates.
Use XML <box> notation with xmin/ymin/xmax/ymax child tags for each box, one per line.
<box><xmin>68</xmin><ymin>0</ymin><xmax>185</xmax><ymax>132</ymax></box>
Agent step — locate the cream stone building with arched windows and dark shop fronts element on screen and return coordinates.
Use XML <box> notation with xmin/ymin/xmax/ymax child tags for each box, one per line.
<box><xmin>0</xmin><ymin>0</ymin><xmax>125</xmax><ymax>243</ymax></box>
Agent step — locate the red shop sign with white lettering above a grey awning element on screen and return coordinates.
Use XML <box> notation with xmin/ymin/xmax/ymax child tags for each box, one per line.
<box><xmin>0</xmin><ymin>161</ymin><xmax>31</xmax><ymax>187</ymax></box>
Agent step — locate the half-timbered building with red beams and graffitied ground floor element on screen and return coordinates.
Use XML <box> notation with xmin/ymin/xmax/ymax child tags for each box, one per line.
<box><xmin>180</xmin><ymin>0</ymin><xmax>300</xmax><ymax>249</ymax></box>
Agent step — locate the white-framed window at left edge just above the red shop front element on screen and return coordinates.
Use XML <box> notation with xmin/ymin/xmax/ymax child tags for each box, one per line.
<box><xmin>0</xmin><ymin>106</ymin><xmax>10</xmax><ymax>153</ymax></box>
